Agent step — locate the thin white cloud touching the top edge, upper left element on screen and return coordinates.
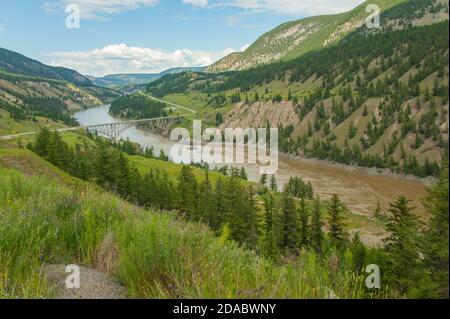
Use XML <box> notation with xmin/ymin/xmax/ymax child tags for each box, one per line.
<box><xmin>44</xmin><ymin>0</ymin><xmax>159</xmax><ymax>19</ymax></box>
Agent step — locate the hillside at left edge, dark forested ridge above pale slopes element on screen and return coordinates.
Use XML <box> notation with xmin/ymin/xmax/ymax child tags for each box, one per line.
<box><xmin>0</xmin><ymin>48</ymin><xmax>120</xmax><ymax>128</ymax></box>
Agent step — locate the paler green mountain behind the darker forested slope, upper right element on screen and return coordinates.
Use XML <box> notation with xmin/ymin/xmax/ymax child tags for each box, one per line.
<box><xmin>207</xmin><ymin>0</ymin><xmax>448</xmax><ymax>72</ymax></box>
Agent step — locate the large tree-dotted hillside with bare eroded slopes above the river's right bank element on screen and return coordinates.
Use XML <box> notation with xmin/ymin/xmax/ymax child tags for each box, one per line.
<box><xmin>143</xmin><ymin>1</ymin><xmax>449</xmax><ymax>176</ymax></box>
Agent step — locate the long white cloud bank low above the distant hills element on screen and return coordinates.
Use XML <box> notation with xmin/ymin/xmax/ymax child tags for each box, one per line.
<box><xmin>48</xmin><ymin>44</ymin><xmax>236</xmax><ymax>76</ymax></box>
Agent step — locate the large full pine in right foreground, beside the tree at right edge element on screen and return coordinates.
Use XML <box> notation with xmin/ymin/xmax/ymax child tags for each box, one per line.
<box><xmin>384</xmin><ymin>196</ymin><xmax>419</xmax><ymax>294</ymax></box>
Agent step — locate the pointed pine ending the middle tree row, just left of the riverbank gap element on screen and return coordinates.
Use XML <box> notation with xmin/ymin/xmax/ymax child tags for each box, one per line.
<box><xmin>328</xmin><ymin>194</ymin><xmax>348</xmax><ymax>248</ymax></box>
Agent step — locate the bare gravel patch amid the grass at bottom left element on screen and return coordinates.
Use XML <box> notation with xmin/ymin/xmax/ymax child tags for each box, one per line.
<box><xmin>44</xmin><ymin>265</ymin><xmax>126</xmax><ymax>299</ymax></box>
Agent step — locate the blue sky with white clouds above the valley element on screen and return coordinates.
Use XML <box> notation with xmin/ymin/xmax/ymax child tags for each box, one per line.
<box><xmin>0</xmin><ymin>0</ymin><xmax>363</xmax><ymax>76</ymax></box>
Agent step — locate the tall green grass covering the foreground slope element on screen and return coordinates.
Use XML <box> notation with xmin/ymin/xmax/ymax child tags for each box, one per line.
<box><xmin>0</xmin><ymin>169</ymin><xmax>380</xmax><ymax>298</ymax></box>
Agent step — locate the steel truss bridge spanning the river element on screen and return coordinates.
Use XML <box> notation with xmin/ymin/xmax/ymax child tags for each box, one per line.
<box><xmin>82</xmin><ymin>116</ymin><xmax>184</xmax><ymax>139</ymax></box>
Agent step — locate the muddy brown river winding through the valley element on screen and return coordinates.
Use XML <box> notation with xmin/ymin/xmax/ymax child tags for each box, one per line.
<box><xmin>75</xmin><ymin>105</ymin><xmax>426</xmax><ymax>216</ymax></box>
